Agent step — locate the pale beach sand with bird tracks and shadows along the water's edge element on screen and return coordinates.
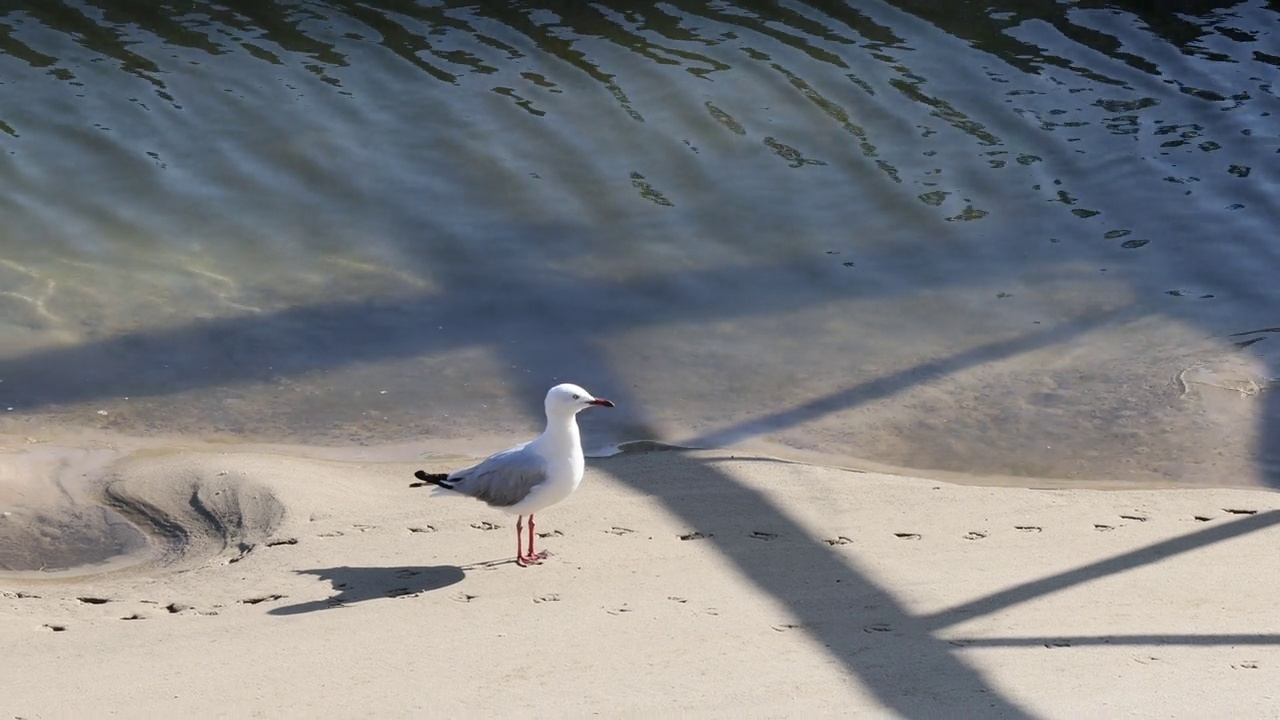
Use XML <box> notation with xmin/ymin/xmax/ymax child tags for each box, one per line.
<box><xmin>0</xmin><ymin>447</ymin><xmax>1280</xmax><ymax>719</ymax></box>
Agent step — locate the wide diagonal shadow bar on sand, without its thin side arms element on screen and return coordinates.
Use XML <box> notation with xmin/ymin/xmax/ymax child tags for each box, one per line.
<box><xmin>596</xmin><ymin>452</ymin><xmax>1030</xmax><ymax>717</ymax></box>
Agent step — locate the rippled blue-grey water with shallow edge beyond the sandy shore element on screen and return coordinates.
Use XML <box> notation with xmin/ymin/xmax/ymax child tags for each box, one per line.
<box><xmin>0</xmin><ymin>0</ymin><xmax>1280</xmax><ymax>486</ymax></box>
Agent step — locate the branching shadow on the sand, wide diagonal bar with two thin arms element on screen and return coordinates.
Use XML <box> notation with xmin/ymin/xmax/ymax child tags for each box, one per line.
<box><xmin>593</xmin><ymin>452</ymin><xmax>1280</xmax><ymax>717</ymax></box>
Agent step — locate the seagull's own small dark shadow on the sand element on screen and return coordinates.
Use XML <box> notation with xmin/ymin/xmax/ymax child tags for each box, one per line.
<box><xmin>269</xmin><ymin>565</ymin><xmax>466</xmax><ymax>615</ymax></box>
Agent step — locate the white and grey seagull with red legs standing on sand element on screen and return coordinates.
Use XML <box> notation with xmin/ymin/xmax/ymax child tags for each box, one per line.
<box><xmin>410</xmin><ymin>383</ymin><xmax>613</xmax><ymax>568</ymax></box>
